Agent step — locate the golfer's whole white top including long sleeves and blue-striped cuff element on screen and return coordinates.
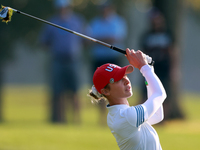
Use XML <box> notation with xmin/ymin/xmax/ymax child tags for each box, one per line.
<box><xmin>107</xmin><ymin>65</ymin><xmax>166</xmax><ymax>150</ymax></box>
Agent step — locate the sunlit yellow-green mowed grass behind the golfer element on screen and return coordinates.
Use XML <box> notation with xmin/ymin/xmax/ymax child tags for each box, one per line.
<box><xmin>0</xmin><ymin>86</ymin><xmax>200</xmax><ymax>150</ymax></box>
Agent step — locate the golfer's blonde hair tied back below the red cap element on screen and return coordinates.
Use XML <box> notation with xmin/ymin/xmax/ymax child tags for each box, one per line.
<box><xmin>88</xmin><ymin>84</ymin><xmax>110</xmax><ymax>103</ymax></box>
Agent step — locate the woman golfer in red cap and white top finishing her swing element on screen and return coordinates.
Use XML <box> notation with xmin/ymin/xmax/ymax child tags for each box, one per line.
<box><xmin>90</xmin><ymin>49</ymin><xmax>166</xmax><ymax>150</ymax></box>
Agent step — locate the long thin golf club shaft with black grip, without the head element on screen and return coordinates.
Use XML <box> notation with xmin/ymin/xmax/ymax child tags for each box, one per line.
<box><xmin>13</xmin><ymin>9</ymin><xmax>126</xmax><ymax>54</ymax></box>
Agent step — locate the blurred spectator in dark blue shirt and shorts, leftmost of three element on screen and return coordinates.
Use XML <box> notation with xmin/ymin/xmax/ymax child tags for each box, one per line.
<box><xmin>40</xmin><ymin>0</ymin><xmax>84</xmax><ymax>122</ymax></box>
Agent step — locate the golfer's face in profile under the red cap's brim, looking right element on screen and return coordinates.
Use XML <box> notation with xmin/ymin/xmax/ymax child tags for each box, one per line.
<box><xmin>110</xmin><ymin>75</ymin><xmax>132</xmax><ymax>99</ymax></box>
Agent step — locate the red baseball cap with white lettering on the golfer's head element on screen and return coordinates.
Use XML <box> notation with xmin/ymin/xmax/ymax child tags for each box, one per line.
<box><xmin>93</xmin><ymin>63</ymin><xmax>134</xmax><ymax>93</ymax></box>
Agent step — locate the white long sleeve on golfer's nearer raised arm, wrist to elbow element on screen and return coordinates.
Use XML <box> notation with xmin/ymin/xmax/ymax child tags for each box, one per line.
<box><xmin>140</xmin><ymin>65</ymin><xmax>166</xmax><ymax>119</ymax></box>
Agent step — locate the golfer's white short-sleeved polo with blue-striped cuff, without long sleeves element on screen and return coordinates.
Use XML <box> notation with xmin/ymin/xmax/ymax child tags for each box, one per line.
<box><xmin>107</xmin><ymin>105</ymin><xmax>162</xmax><ymax>150</ymax></box>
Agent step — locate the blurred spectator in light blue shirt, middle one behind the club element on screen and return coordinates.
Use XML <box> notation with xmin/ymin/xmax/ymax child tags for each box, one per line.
<box><xmin>88</xmin><ymin>2</ymin><xmax>127</xmax><ymax>124</ymax></box>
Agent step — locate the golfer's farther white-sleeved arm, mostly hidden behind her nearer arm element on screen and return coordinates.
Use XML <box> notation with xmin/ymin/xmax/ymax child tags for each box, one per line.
<box><xmin>147</xmin><ymin>82</ymin><xmax>164</xmax><ymax>125</ymax></box>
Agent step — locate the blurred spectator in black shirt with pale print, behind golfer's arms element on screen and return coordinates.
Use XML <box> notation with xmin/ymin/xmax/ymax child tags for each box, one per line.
<box><xmin>141</xmin><ymin>9</ymin><xmax>183</xmax><ymax>119</ymax></box>
